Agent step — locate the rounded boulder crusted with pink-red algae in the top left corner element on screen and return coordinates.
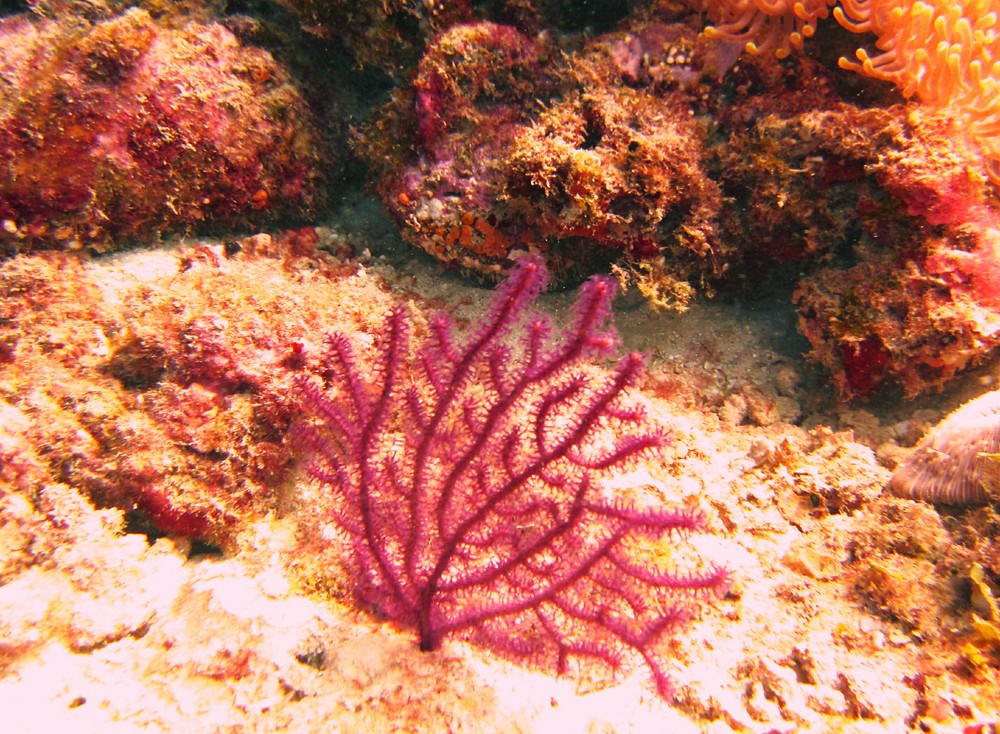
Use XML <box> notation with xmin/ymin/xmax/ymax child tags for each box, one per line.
<box><xmin>0</xmin><ymin>9</ymin><xmax>325</xmax><ymax>252</ymax></box>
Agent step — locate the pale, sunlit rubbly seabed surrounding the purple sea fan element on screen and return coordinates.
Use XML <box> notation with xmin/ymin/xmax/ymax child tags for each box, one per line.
<box><xmin>0</xmin><ymin>227</ymin><xmax>1000</xmax><ymax>733</ymax></box>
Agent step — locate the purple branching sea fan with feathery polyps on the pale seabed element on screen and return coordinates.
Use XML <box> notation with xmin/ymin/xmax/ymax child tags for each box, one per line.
<box><xmin>297</xmin><ymin>257</ymin><xmax>729</xmax><ymax>695</ymax></box>
